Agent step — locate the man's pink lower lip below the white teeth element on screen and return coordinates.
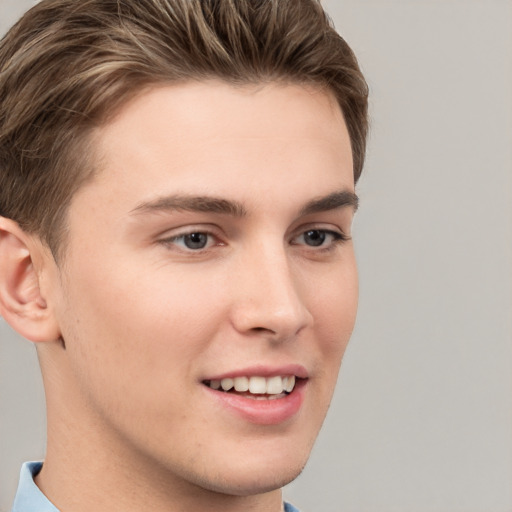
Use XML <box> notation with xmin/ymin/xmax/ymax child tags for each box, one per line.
<box><xmin>204</xmin><ymin>380</ymin><xmax>307</xmax><ymax>425</ymax></box>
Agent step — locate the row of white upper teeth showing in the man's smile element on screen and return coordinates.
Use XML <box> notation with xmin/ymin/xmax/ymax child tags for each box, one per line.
<box><xmin>206</xmin><ymin>375</ymin><xmax>295</xmax><ymax>399</ymax></box>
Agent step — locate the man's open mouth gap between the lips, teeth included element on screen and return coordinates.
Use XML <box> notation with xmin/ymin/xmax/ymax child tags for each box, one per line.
<box><xmin>203</xmin><ymin>375</ymin><xmax>304</xmax><ymax>400</ymax></box>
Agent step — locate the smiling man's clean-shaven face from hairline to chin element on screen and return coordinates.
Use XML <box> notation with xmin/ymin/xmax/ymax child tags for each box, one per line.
<box><xmin>43</xmin><ymin>82</ymin><xmax>357</xmax><ymax>495</ymax></box>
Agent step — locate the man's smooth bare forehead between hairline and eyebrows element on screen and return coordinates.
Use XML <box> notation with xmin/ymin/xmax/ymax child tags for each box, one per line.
<box><xmin>74</xmin><ymin>81</ymin><xmax>353</xmax><ymax>220</ymax></box>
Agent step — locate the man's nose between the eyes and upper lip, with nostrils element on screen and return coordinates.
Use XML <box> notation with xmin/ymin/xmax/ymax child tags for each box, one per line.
<box><xmin>232</xmin><ymin>243</ymin><xmax>313</xmax><ymax>341</ymax></box>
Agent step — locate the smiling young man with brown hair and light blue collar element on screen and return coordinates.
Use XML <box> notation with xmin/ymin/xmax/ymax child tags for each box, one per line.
<box><xmin>0</xmin><ymin>0</ymin><xmax>367</xmax><ymax>512</ymax></box>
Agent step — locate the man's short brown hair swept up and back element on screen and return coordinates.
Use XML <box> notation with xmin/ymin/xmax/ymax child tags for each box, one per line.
<box><xmin>0</xmin><ymin>0</ymin><xmax>368</xmax><ymax>256</ymax></box>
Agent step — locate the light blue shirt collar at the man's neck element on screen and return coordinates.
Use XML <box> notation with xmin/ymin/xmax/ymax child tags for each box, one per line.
<box><xmin>11</xmin><ymin>462</ymin><xmax>299</xmax><ymax>512</ymax></box>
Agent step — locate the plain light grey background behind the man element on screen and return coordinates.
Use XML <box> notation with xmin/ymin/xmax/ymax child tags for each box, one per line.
<box><xmin>0</xmin><ymin>0</ymin><xmax>512</xmax><ymax>512</ymax></box>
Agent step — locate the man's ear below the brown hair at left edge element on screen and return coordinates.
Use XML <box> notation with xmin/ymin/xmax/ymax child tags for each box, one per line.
<box><xmin>0</xmin><ymin>217</ymin><xmax>60</xmax><ymax>342</ymax></box>
